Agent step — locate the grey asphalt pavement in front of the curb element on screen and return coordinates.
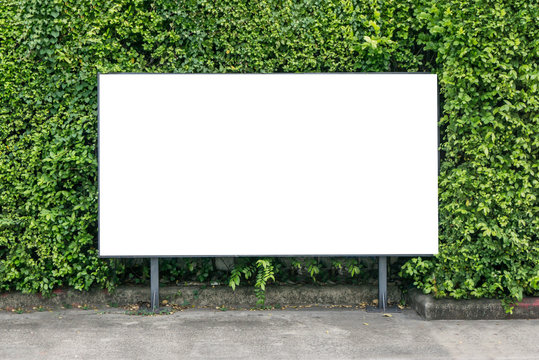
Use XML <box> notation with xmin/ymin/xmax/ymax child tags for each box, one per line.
<box><xmin>0</xmin><ymin>308</ymin><xmax>539</xmax><ymax>359</ymax></box>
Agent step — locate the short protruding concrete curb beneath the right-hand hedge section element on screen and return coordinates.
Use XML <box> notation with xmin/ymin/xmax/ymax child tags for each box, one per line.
<box><xmin>405</xmin><ymin>289</ymin><xmax>539</xmax><ymax>320</ymax></box>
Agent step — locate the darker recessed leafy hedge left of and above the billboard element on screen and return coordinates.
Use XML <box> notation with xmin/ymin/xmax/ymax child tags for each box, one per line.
<box><xmin>0</xmin><ymin>0</ymin><xmax>421</xmax><ymax>293</ymax></box>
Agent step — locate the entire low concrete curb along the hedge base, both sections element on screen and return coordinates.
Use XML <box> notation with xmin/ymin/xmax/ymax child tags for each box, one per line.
<box><xmin>5</xmin><ymin>285</ymin><xmax>539</xmax><ymax>320</ymax></box>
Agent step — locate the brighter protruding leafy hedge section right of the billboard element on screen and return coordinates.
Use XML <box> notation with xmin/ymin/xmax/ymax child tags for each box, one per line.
<box><xmin>402</xmin><ymin>0</ymin><xmax>539</xmax><ymax>310</ymax></box>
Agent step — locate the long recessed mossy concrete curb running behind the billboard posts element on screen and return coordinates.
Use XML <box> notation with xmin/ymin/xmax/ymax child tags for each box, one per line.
<box><xmin>0</xmin><ymin>285</ymin><xmax>401</xmax><ymax>309</ymax></box>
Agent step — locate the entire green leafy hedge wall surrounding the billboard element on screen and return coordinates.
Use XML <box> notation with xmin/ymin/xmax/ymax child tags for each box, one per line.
<box><xmin>0</xmin><ymin>0</ymin><xmax>539</xmax><ymax>306</ymax></box>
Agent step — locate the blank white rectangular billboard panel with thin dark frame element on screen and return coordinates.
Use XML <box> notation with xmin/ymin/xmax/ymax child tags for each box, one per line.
<box><xmin>98</xmin><ymin>73</ymin><xmax>438</xmax><ymax>257</ymax></box>
